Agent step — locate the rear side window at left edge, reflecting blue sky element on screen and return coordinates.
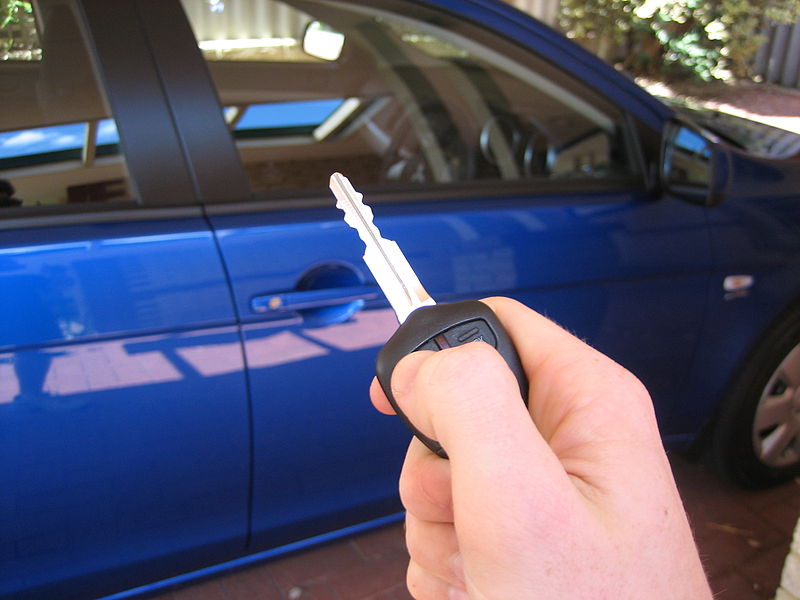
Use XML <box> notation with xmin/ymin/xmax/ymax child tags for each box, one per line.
<box><xmin>0</xmin><ymin>0</ymin><xmax>131</xmax><ymax>211</ymax></box>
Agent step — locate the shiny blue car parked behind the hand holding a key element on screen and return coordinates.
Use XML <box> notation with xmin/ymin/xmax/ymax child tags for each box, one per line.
<box><xmin>0</xmin><ymin>0</ymin><xmax>800</xmax><ymax>600</ymax></box>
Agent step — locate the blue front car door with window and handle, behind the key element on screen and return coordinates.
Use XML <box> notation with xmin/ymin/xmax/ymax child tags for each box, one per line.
<box><xmin>170</xmin><ymin>0</ymin><xmax>710</xmax><ymax>548</ymax></box>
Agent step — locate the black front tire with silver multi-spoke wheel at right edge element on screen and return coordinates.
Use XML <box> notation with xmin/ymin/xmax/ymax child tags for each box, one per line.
<box><xmin>711</xmin><ymin>307</ymin><xmax>800</xmax><ymax>488</ymax></box>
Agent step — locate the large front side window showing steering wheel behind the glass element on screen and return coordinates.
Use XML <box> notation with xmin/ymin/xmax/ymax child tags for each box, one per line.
<box><xmin>182</xmin><ymin>0</ymin><xmax>631</xmax><ymax>190</ymax></box>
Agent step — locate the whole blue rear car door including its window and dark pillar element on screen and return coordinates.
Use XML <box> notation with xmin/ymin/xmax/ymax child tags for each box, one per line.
<box><xmin>0</xmin><ymin>0</ymin><xmax>249</xmax><ymax>600</ymax></box>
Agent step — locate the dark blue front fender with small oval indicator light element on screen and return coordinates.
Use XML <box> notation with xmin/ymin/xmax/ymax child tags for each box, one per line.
<box><xmin>687</xmin><ymin>151</ymin><xmax>800</xmax><ymax>432</ymax></box>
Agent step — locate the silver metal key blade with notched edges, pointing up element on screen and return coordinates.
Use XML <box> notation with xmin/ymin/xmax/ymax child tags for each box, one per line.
<box><xmin>330</xmin><ymin>173</ymin><xmax>436</xmax><ymax>323</ymax></box>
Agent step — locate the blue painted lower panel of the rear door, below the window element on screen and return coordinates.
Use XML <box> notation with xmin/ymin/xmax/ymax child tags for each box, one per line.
<box><xmin>0</xmin><ymin>218</ymin><xmax>249</xmax><ymax>598</ymax></box>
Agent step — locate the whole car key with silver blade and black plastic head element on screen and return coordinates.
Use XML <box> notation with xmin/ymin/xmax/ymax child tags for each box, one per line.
<box><xmin>330</xmin><ymin>173</ymin><xmax>528</xmax><ymax>458</ymax></box>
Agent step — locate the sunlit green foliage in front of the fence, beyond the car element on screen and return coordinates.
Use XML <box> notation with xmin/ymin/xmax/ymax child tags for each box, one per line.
<box><xmin>559</xmin><ymin>0</ymin><xmax>800</xmax><ymax>80</ymax></box>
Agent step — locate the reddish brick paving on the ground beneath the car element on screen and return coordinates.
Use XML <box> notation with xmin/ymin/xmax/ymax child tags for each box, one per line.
<box><xmin>156</xmin><ymin>456</ymin><xmax>800</xmax><ymax>600</ymax></box>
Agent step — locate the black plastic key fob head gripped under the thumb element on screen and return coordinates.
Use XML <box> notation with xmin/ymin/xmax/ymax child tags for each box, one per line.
<box><xmin>375</xmin><ymin>300</ymin><xmax>528</xmax><ymax>458</ymax></box>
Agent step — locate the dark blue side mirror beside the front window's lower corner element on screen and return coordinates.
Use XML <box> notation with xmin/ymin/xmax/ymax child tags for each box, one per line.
<box><xmin>661</xmin><ymin>121</ymin><xmax>731</xmax><ymax>206</ymax></box>
